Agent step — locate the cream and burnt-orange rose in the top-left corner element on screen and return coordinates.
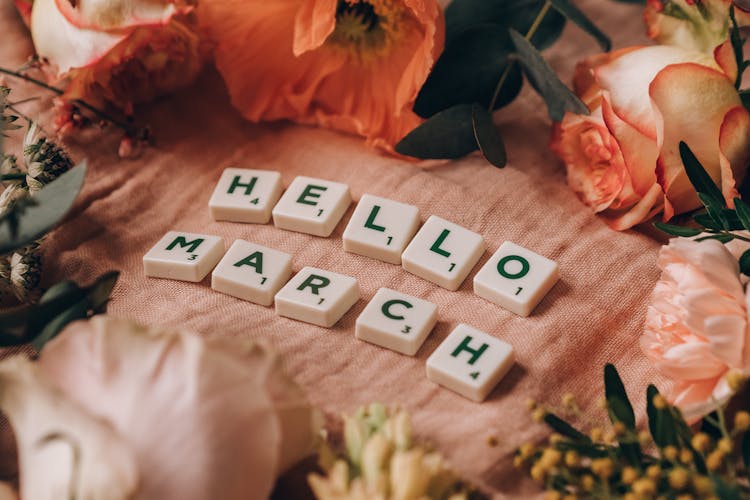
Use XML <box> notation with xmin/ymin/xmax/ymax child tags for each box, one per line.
<box><xmin>31</xmin><ymin>0</ymin><xmax>203</xmax><ymax>112</ymax></box>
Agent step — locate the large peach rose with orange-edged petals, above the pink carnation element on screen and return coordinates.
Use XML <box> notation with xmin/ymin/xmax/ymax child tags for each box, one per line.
<box><xmin>551</xmin><ymin>42</ymin><xmax>750</xmax><ymax>230</ymax></box>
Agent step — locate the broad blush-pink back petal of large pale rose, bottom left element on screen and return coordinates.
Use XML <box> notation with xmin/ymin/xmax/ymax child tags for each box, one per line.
<box><xmin>40</xmin><ymin>316</ymin><xmax>315</xmax><ymax>500</ymax></box>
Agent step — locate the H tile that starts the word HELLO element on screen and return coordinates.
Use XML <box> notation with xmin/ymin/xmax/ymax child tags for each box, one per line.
<box><xmin>208</xmin><ymin>168</ymin><xmax>284</xmax><ymax>224</ymax></box>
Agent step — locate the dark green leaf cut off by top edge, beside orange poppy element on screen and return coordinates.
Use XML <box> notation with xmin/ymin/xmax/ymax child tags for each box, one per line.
<box><xmin>445</xmin><ymin>0</ymin><xmax>565</xmax><ymax>50</ymax></box>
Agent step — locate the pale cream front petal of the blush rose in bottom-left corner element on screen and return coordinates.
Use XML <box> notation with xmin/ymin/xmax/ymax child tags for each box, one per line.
<box><xmin>0</xmin><ymin>356</ymin><xmax>138</xmax><ymax>500</ymax></box>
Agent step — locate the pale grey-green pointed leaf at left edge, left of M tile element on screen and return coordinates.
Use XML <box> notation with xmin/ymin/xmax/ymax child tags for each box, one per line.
<box><xmin>0</xmin><ymin>163</ymin><xmax>86</xmax><ymax>254</ymax></box>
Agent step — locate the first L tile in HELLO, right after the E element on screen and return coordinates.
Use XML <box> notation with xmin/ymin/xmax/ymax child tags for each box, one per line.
<box><xmin>343</xmin><ymin>194</ymin><xmax>419</xmax><ymax>264</ymax></box>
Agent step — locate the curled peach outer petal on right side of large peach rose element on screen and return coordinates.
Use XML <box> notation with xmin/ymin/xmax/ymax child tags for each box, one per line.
<box><xmin>649</xmin><ymin>63</ymin><xmax>741</xmax><ymax>214</ymax></box>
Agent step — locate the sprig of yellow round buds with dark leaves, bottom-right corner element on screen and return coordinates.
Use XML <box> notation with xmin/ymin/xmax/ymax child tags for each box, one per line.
<box><xmin>514</xmin><ymin>365</ymin><xmax>750</xmax><ymax>500</ymax></box>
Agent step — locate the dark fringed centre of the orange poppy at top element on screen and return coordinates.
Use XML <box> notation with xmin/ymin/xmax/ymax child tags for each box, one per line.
<box><xmin>328</xmin><ymin>0</ymin><xmax>404</xmax><ymax>60</ymax></box>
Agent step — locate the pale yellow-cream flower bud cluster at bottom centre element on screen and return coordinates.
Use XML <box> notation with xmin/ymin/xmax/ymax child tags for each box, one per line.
<box><xmin>308</xmin><ymin>403</ymin><xmax>483</xmax><ymax>500</ymax></box>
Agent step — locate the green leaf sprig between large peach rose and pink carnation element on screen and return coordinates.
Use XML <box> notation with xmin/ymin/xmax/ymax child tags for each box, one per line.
<box><xmin>654</xmin><ymin>142</ymin><xmax>750</xmax><ymax>276</ymax></box>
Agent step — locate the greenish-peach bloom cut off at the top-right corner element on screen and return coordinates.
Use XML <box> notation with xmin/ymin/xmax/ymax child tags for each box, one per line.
<box><xmin>643</xmin><ymin>0</ymin><xmax>750</xmax><ymax>53</ymax></box>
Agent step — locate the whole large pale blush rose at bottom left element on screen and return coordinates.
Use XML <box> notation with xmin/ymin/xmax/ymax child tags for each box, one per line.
<box><xmin>0</xmin><ymin>316</ymin><xmax>319</xmax><ymax>500</ymax></box>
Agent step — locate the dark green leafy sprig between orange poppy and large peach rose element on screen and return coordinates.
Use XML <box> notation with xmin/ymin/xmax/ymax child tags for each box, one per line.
<box><xmin>396</xmin><ymin>0</ymin><xmax>641</xmax><ymax>167</ymax></box>
